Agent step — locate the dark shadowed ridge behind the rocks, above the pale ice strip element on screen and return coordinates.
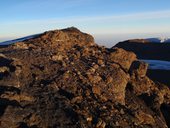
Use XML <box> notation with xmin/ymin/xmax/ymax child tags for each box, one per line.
<box><xmin>114</xmin><ymin>39</ymin><xmax>170</xmax><ymax>61</ymax></box>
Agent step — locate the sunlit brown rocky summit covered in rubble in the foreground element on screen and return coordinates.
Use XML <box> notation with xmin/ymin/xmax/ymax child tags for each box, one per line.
<box><xmin>0</xmin><ymin>27</ymin><xmax>170</xmax><ymax>128</ymax></box>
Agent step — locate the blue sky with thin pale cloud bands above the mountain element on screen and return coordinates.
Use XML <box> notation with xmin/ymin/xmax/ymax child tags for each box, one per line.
<box><xmin>0</xmin><ymin>0</ymin><xmax>170</xmax><ymax>45</ymax></box>
